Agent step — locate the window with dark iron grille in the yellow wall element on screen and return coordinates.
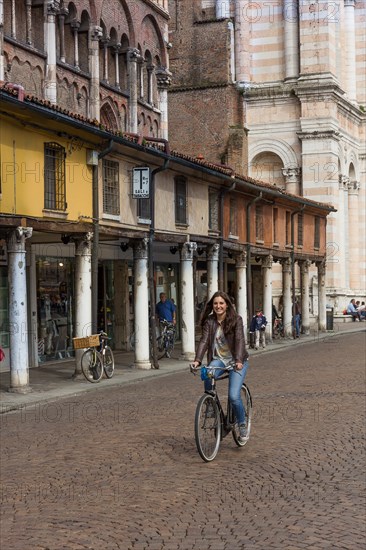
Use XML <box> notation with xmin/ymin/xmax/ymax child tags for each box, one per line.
<box><xmin>44</xmin><ymin>143</ymin><xmax>67</xmax><ymax>210</ymax></box>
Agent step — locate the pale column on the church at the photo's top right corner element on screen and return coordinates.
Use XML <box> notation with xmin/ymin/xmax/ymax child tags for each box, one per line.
<box><xmin>344</xmin><ymin>0</ymin><xmax>357</xmax><ymax>102</ymax></box>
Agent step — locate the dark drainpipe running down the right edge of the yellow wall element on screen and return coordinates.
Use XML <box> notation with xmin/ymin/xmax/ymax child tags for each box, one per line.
<box><xmin>91</xmin><ymin>139</ymin><xmax>114</xmax><ymax>334</ymax></box>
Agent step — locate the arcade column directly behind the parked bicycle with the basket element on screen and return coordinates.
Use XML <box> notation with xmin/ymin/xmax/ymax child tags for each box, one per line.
<box><xmin>73</xmin><ymin>233</ymin><xmax>93</xmax><ymax>379</ymax></box>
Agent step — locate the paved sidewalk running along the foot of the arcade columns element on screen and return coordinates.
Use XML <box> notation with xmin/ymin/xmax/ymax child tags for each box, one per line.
<box><xmin>0</xmin><ymin>322</ymin><xmax>366</xmax><ymax>413</ymax></box>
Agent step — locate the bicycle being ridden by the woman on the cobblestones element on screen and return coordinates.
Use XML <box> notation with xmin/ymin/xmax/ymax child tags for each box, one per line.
<box><xmin>190</xmin><ymin>365</ymin><xmax>253</xmax><ymax>462</ymax></box>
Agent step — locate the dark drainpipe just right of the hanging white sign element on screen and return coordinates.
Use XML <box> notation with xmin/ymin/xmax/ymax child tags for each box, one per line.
<box><xmin>148</xmin><ymin>159</ymin><xmax>169</xmax><ymax>369</ymax></box>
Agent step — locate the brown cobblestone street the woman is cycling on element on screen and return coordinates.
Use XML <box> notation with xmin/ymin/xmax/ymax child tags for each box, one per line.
<box><xmin>0</xmin><ymin>332</ymin><xmax>366</xmax><ymax>550</ymax></box>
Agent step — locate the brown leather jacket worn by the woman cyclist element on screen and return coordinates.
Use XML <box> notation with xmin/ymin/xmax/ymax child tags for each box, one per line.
<box><xmin>195</xmin><ymin>315</ymin><xmax>249</xmax><ymax>364</ymax></box>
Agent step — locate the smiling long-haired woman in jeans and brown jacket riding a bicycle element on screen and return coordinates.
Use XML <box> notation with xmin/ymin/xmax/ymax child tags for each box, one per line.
<box><xmin>193</xmin><ymin>291</ymin><xmax>249</xmax><ymax>439</ymax></box>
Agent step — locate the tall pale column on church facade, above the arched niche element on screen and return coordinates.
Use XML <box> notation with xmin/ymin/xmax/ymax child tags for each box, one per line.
<box><xmin>283</xmin><ymin>0</ymin><xmax>300</xmax><ymax>78</ymax></box>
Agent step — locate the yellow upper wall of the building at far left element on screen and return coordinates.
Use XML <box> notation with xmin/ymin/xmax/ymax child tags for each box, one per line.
<box><xmin>0</xmin><ymin>120</ymin><xmax>92</xmax><ymax>221</ymax></box>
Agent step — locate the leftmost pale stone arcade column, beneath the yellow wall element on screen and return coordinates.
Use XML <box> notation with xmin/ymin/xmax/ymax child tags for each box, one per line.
<box><xmin>7</xmin><ymin>227</ymin><xmax>33</xmax><ymax>393</ymax></box>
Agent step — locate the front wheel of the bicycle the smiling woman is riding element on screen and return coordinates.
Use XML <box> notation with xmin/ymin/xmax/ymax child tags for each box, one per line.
<box><xmin>194</xmin><ymin>394</ymin><xmax>221</xmax><ymax>462</ymax></box>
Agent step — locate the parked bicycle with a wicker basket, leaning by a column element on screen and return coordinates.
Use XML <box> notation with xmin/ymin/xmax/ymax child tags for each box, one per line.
<box><xmin>73</xmin><ymin>331</ymin><xmax>114</xmax><ymax>383</ymax></box>
